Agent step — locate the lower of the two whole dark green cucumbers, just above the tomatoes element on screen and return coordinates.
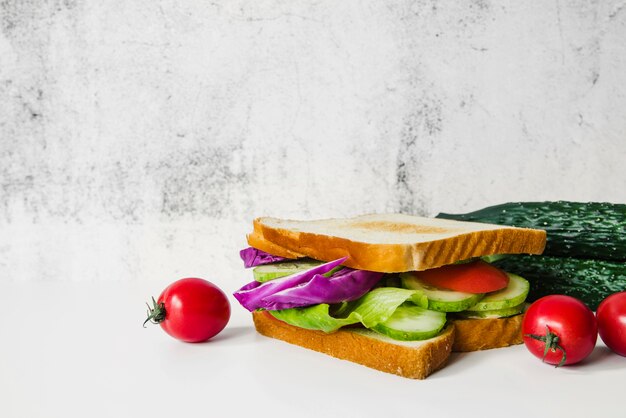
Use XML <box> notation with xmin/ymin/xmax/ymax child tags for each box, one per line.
<box><xmin>494</xmin><ymin>255</ymin><xmax>626</xmax><ymax>311</ymax></box>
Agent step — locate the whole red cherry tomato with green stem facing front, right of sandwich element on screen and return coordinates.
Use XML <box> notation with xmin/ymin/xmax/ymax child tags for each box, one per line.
<box><xmin>522</xmin><ymin>295</ymin><xmax>598</xmax><ymax>367</ymax></box>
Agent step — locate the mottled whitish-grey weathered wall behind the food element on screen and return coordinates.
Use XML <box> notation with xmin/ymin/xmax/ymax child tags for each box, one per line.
<box><xmin>0</xmin><ymin>0</ymin><xmax>626</xmax><ymax>280</ymax></box>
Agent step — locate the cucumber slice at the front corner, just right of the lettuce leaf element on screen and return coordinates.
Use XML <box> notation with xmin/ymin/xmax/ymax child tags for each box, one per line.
<box><xmin>372</xmin><ymin>305</ymin><xmax>446</xmax><ymax>341</ymax></box>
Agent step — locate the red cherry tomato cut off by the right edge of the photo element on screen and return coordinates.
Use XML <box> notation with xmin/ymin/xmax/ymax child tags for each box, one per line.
<box><xmin>596</xmin><ymin>291</ymin><xmax>626</xmax><ymax>356</ymax></box>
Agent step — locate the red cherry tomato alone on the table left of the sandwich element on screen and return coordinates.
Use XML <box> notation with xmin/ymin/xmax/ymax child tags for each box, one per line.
<box><xmin>144</xmin><ymin>278</ymin><xmax>230</xmax><ymax>343</ymax></box>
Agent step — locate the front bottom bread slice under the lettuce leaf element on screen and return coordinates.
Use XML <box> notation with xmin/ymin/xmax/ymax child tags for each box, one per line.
<box><xmin>252</xmin><ymin>312</ymin><xmax>454</xmax><ymax>379</ymax></box>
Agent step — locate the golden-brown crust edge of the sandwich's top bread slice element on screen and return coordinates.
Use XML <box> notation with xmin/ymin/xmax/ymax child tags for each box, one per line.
<box><xmin>248</xmin><ymin>214</ymin><xmax>546</xmax><ymax>273</ymax></box>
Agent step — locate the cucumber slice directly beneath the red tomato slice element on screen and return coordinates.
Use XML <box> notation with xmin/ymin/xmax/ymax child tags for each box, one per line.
<box><xmin>400</xmin><ymin>273</ymin><xmax>483</xmax><ymax>312</ymax></box>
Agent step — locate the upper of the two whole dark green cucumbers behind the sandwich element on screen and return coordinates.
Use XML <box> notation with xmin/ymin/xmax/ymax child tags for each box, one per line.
<box><xmin>437</xmin><ymin>201</ymin><xmax>626</xmax><ymax>261</ymax></box>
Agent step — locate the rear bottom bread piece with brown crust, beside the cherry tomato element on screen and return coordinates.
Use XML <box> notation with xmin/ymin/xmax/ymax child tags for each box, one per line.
<box><xmin>450</xmin><ymin>314</ymin><xmax>524</xmax><ymax>352</ymax></box>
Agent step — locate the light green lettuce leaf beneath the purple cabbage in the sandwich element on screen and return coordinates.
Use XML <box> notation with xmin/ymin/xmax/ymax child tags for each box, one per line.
<box><xmin>268</xmin><ymin>287</ymin><xmax>428</xmax><ymax>332</ymax></box>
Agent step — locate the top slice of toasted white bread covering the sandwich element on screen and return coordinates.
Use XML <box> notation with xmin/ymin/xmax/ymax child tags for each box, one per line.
<box><xmin>248</xmin><ymin>214</ymin><xmax>546</xmax><ymax>273</ymax></box>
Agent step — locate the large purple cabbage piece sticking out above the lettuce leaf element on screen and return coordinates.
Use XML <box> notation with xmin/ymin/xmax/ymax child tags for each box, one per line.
<box><xmin>234</xmin><ymin>258</ymin><xmax>383</xmax><ymax>312</ymax></box>
